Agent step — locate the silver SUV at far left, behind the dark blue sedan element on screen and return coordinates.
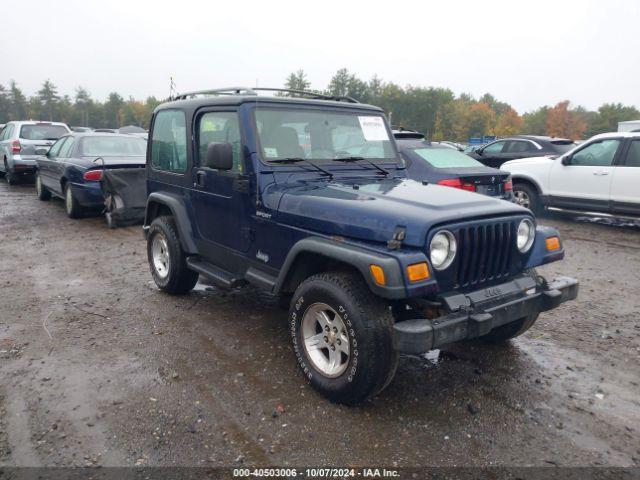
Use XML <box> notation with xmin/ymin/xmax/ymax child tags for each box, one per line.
<box><xmin>0</xmin><ymin>121</ymin><xmax>71</xmax><ymax>185</ymax></box>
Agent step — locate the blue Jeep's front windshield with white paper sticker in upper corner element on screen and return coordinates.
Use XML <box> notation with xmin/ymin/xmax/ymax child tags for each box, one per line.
<box><xmin>255</xmin><ymin>108</ymin><xmax>396</xmax><ymax>161</ymax></box>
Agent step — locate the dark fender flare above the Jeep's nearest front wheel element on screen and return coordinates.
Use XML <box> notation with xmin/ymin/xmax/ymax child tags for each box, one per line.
<box><xmin>274</xmin><ymin>237</ymin><xmax>406</xmax><ymax>299</ymax></box>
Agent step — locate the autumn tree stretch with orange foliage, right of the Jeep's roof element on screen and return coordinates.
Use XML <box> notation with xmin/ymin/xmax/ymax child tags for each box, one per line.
<box><xmin>285</xmin><ymin>68</ymin><xmax>640</xmax><ymax>141</ymax></box>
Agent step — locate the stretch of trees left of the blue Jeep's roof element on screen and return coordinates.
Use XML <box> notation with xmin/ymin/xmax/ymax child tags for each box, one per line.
<box><xmin>0</xmin><ymin>80</ymin><xmax>160</xmax><ymax>128</ymax></box>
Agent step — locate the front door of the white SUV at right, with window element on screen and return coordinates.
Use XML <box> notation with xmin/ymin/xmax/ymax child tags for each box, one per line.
<box><xmin>548</xmin><ymin>138</ymin><xmax>622</xmax><ymax>211</ymax></box>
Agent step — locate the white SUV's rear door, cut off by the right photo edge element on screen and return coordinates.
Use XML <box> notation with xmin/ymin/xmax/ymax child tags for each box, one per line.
<box><xmin>611</xmin><ymin>138</ymin><xmax>640</xmax><ymax>215</ymax></box>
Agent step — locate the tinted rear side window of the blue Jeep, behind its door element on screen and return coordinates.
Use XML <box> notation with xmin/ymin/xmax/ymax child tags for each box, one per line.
<box><xmin>151</xmin><ymin>110</ymin><xmax>187</xmax><ymax>173</ymax></box>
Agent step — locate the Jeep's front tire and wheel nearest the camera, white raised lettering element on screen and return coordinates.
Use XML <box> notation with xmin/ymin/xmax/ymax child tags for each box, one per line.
<box><xmin>289</xmin><ymin>272</ymin><xmax>398</xmax><ymax>405</ymax></box>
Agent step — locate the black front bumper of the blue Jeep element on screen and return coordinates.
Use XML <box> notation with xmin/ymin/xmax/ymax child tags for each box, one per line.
<box><xmin>394</xmin><ymin>275</ymin><xmax>578</xmax><ymax>354</ymax></box>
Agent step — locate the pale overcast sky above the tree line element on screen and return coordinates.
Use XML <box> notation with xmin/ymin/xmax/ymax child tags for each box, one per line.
<box><xmin>0</xmin><ymin>0</ymin><xmax>640</xmax><ymax>113</ymax></box>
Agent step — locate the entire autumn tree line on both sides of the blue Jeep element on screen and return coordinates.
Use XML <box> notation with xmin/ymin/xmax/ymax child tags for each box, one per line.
<box><xmin>0</xmin><ymin>73</ymin><xmax>640</xmax><ymax>141</ymax></box>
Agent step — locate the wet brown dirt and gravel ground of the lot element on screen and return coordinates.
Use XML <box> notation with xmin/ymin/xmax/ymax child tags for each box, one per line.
<box><xmin>0</xmin><ymin>182</ymin><xmax>640</xmax><ymax>467</ymax></box>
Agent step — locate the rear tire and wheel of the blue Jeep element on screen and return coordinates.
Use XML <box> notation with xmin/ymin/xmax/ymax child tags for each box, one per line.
<box><xmin>147</xmin><ymin>216</ymin><xmax>198</xmax><ymax>295</ymax></box>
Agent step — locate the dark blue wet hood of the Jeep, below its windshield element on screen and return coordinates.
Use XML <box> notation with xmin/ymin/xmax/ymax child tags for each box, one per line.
<box><xmin>265</xmin><ymin>178</ymin><xmax>530</xmax><ymax>247</ymax></box>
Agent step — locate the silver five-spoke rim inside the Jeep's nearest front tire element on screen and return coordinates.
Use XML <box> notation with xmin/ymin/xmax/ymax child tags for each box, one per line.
<box><xmin>301</xmin><ymin>303</ymin><xmax>351</xmax><ymax>378</ymax></box>
